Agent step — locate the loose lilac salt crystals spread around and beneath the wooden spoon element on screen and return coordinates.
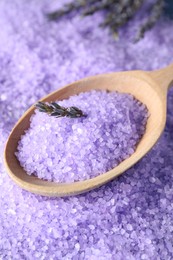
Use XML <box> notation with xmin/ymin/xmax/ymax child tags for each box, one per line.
<box><xmin>0</xmin><ymin>0</ymin><xmax>173</xmax><ymax>260</ymax></box>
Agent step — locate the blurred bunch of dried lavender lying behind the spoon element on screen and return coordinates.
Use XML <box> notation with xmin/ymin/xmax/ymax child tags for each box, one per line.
<box><xmin>47</xmin><ymin>0</ymin><xmax>164</xmax><ymax>42</ymax></box>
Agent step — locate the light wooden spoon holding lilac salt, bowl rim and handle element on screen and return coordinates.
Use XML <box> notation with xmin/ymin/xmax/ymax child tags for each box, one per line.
<box><xmin>4</xmin><ymin>64</ymin><xmax>173</xmax><ymax>196</ymax></box>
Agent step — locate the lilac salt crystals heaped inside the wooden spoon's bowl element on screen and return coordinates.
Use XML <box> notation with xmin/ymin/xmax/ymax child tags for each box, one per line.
<box><xmin>16</xmin><ymin>90</ymin><xmax>147</xmax><ymax>182</ymax></box>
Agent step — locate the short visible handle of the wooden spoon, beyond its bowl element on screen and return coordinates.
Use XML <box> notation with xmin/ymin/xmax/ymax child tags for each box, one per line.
<box><xmin>149</xmin><ymin>64</ymin><xmax>173</xmax><ymax>91</ymax></box>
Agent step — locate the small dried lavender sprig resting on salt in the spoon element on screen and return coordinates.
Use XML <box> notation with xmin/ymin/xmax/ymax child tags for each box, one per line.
<box><xmin>35</xmin><ymin>102</ymin><xmax>86</xmax><ymax>118</ymax></box>
